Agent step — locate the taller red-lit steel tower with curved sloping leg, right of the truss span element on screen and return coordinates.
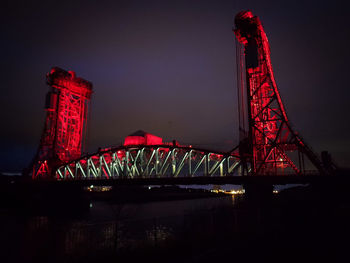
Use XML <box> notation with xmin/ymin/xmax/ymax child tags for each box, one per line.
<box><xmin>234</xmin><ymin>11</ymin><xmax>325</xmax><ymax>175</ymax></box>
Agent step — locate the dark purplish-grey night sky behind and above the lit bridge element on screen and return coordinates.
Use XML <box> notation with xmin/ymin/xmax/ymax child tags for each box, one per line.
<box><xmin>0</xmin><ymin>0</ymin><xmax>350</xmax><ymax>171</ymax></box>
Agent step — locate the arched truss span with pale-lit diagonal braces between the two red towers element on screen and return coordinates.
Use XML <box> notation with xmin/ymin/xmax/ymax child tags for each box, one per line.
<box><xmin>55</xmin><ymin>145</ymin><xmax>242</xmax><ymax>180</ymax></box>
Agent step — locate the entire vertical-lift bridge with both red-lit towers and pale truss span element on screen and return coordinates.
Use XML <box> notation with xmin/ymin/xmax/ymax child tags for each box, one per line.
<box><xmin>31</xmin><ymin>11</ymin><xmax>335</xmax><ymax>184</ymax></box>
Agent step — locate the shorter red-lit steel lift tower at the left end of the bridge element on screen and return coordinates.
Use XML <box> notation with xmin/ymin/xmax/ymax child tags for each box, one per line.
<box><xmin>32</xmin><ymin>67</ymin><xmax>92</xmax><ymax>178</ymax></box>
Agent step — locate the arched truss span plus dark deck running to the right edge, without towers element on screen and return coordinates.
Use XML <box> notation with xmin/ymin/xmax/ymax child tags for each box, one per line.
<box><xmin>54</xmin><ymin>144</ymin><xmax>334</xmax><ymax>186</ymax></box>
